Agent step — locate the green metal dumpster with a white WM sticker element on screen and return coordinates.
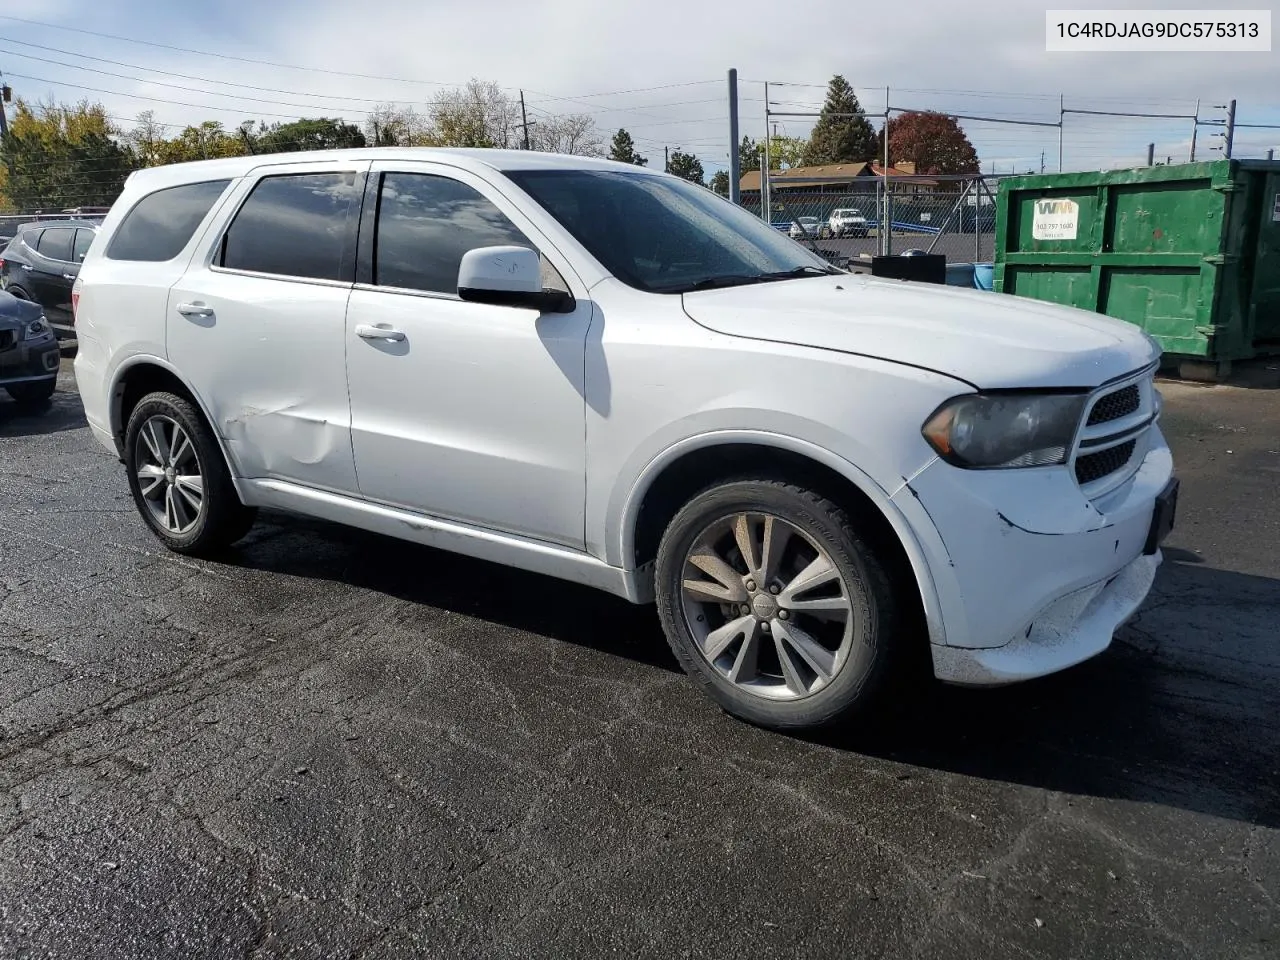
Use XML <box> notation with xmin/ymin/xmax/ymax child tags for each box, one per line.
<box><xmin>995</xmin><ymin>160</ymin><xmax>1280</xmax><ymax>379</ymax></box>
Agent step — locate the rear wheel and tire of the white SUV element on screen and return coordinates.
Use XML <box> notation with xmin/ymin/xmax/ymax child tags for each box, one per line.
<box><xmin>124</xmin><ymin>393</ymin><xmax>257</xmax><ymax>556</ymax></box>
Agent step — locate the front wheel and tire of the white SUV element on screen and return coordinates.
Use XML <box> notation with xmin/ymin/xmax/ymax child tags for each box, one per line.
<box><xmin>655</xmin><ymin>476</ymin><xmax>899</xmax><ymax>731</ymax></box>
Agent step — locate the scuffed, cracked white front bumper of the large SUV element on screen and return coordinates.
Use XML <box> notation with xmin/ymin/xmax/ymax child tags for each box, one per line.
<box><xmin>895</xmin><ymin>426</ymin><xmax>1172</xmax><ymax>685</ymax></box>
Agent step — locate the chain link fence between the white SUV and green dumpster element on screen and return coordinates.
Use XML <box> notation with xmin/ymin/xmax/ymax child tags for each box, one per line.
<box><xmin>740</xmin><ymin>175</ymin><xmax>998</xmax><ymax>266</ymax></box>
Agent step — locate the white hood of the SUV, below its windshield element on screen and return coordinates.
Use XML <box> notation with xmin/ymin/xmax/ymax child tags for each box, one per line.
<box><xmin>684</xmin><ymin>274</ymin><xmax>1160</xmax><ymax>389</ymax></box>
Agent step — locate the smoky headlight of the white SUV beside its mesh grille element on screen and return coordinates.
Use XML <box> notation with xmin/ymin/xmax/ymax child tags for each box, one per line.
<box><xmin>922</xmin><ymin>393</ymin><xmax>1085</xmax><ymax>468</ymax></box>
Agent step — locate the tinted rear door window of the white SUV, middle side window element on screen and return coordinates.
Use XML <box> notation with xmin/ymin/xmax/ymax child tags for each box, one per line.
<box><xmin>219</xmin><ymin>173</ymin><xmax>362</xmax><ymax>280</ymax></box>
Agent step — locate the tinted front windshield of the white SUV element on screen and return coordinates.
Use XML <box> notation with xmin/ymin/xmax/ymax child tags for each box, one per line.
<box><xmin>507</xmin><ymin>170</ymin><xmax>838</xmax><ymax>293</ymax></box>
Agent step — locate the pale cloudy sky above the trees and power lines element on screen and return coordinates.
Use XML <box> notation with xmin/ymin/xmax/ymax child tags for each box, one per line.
<box><xmin>0</xmin><ymin>0</ymin><xmax>1280</xmax><ymax>174</ymax></box>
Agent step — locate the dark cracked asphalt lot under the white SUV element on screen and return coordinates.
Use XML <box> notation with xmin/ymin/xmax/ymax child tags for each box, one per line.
<box><xmin>0</xmin><ymin>361</ymin><xmax>1280</xmax><ymax>960</ymax></box>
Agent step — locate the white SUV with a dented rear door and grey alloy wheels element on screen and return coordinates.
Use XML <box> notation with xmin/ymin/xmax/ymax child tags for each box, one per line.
<box><xmin>67</xmin><ymin>148</ymin><xmax>1176</xmax><ymax>728</ymax></box>
